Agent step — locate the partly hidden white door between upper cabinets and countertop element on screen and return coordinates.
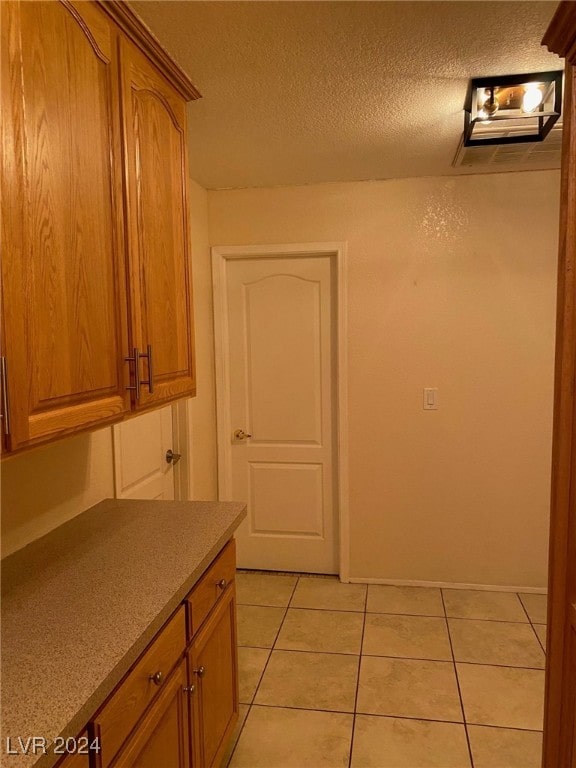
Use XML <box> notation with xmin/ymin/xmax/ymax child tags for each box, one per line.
<box><xmin>114</xmin><ymin>406</ymin><xmax>174</xmax><ymax>499</ymax></box>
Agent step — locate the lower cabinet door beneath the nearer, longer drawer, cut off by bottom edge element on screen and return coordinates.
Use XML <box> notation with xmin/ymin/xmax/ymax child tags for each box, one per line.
<box><xmin>114</xmin><ymin>661</ymin><xmax>190</xmax><ymax>768</ymax></box>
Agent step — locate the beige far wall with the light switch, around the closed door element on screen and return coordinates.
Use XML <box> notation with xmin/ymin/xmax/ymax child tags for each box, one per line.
<box><xmin>209</xmin><ymin>172</ymin><xmax>559</xmax><ymax>587</ymax></box>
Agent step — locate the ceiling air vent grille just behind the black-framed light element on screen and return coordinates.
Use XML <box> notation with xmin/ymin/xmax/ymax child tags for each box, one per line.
<box><xmin>452</xmin><ymin>123</ymin><xmax>562</xmax><ymax>173</ymax></box>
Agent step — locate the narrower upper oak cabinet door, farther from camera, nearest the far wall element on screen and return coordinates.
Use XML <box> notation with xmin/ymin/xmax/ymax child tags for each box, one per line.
<box><xmin>121</xmin><ymin>40</ymin><xmax>196</xmax><ymax>408</ymax></box>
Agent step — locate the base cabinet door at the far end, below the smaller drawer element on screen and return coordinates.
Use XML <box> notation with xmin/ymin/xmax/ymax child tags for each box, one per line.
<box><xmin>188</xmin><ymin>582</ymin><xmax>238</xmax><ymax>768</ymax></box>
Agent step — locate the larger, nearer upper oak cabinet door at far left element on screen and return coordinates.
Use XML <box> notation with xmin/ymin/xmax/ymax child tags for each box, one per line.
<box><xmin>1</xmin><ymin>2</ymin><xmax>130</xmax><ymax>449</ymax></box>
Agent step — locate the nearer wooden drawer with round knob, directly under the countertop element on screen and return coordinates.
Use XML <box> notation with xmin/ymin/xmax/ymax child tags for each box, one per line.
<box><xmin>93</xmin><ymin>606</ymin><xmax>186</xmax><ymax>768</ymax></box>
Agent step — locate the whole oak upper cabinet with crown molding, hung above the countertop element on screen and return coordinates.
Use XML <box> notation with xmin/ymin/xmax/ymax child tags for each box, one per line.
<box><xmin>0</xmin><ymin>0</ymin><xmax>200</xmax><ymax>451</ymax></box>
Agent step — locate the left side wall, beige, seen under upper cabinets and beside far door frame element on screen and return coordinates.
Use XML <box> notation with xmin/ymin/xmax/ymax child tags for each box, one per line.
<box><xmin>0</xmin><ymin>182</ymin><xmax>217</xmax><ymax>557</ymax></box>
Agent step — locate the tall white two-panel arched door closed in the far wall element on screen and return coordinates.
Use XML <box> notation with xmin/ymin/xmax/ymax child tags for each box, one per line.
<box><xmin>226</xmin><ymin>256</ymin><xmax>338</xmax><ymax>573</ymax></box>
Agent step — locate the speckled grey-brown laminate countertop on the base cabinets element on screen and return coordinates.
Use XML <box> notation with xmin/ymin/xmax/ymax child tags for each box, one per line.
<box><xmin>0</xmin><ymin>500</ymin><xmax>246</xmax><ymax>768</ymax></box>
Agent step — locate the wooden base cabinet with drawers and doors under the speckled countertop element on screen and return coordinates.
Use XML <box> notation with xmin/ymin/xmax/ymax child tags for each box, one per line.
<box><xmin>80</xmin><ymin>540</ymin><xmax>238</xmax><ymax>768</ymax></box>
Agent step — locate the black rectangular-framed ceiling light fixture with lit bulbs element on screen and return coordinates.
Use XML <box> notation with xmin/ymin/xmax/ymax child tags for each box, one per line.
<box><xmin>464</xmin><ymin>71</ymin><xmax>563</xmax><ymax>147</ymax></box>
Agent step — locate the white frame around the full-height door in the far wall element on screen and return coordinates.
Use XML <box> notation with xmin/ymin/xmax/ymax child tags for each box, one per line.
<box><xmin>212</xmin><ymin>243</ymin><xmax>350</xmax><ymax>582</ymax></box>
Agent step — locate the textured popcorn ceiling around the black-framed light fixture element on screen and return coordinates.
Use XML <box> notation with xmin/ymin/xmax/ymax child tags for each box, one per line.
<box><xmin>131</xmin><ymin>0</ymin><xmax>562</xmax><ymax>189</ymax></box>
